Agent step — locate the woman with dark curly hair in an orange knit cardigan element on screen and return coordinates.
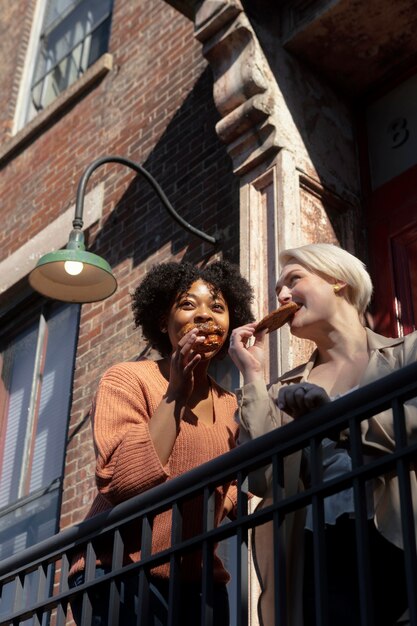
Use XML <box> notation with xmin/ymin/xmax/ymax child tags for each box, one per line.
<box><xmin>70</xmin><ymin>261</ymin><xmax>253</xmax><ymax>626</ymax></box>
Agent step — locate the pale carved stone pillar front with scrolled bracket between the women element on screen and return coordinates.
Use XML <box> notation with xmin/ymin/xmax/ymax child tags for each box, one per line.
<box><xmin>195</xmin><ymin>0</ymin><xmax>301</xmax><ymax>380</ymax></box>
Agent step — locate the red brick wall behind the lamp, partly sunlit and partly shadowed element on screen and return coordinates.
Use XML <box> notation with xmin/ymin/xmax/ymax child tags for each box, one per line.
<box><xmin>0</xmin><ymin>0</ymin><xmax>239</xmax><ymax>528</ymax></box>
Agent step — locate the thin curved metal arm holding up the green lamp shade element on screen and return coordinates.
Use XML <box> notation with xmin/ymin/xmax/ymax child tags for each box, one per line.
<box><xmin>72</xmin><ymin>156</ymin><xmax>218</xmax><ymax>245</ymax></box>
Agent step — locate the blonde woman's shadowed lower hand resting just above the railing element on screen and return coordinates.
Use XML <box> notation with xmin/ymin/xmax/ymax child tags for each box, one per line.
<box><xmin>276</xmin><ymin>383</ymin><xmax>330</xmax><ymax>419</ymax></box>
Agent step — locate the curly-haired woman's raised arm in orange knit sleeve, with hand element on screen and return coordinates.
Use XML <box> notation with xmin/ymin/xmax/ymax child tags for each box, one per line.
<box><xmin>93</xmin><ymin>329</ymin><xmax>216</xmax><ymax>503</ymax></box>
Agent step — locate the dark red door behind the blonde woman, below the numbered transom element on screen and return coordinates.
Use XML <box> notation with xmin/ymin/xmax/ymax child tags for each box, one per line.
<box><xmin>367</xmin><ymin>166</ymin><xmax>417</xmax><ymax>337</ymax></box>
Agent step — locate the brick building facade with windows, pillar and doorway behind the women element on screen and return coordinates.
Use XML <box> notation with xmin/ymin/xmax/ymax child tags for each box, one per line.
<box><xmin>0</xmin><ymin>0</ymin><xmax>417</xmax><ymax>620</ymax></box>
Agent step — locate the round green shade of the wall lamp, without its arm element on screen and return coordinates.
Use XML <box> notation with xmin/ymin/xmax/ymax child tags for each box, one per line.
<box><xmin>29</xmin><ymin>249</ymin><xmax>117</xmax><ymax>303</ymax></box>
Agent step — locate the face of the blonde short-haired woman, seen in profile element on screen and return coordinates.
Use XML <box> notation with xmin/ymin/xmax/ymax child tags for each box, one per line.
<box><xmin>276</xmin><ymin>260</ymin><xmax>340</xmax><ymax>339</ymax></box>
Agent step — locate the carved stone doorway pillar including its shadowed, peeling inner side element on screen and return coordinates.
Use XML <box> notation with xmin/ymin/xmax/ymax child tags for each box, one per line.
<box><xmin>195</xmin><ymin>0</ymin><xmax>359</xmax><ymax>625</ymax></box>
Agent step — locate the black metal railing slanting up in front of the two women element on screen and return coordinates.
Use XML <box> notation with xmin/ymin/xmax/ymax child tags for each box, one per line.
<box><xmin>0</xmin><ymin>364</ymin><xmax>417</xmax><ymax>626</ymax></box>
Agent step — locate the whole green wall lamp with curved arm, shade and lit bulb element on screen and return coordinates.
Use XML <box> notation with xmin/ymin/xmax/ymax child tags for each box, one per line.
<box><xmin>29</xmin><ymin>156</ymin><xmax>217</xmax><ymax>303</ymax></box>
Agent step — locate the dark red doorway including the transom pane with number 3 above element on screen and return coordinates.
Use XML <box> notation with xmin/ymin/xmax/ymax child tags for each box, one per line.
<box><xmin>363</xmin><ymin>74</ymin><xmax>417</xmax><ymax>337</ymax></box>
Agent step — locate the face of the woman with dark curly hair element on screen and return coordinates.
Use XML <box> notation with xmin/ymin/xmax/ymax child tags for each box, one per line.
<box><xmin>166</xmin><ymin>279</ymin><xmax>229</xmax><ymax>359</ymax></box>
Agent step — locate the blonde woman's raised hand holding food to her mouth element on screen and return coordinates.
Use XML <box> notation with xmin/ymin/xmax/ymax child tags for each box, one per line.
<box><xmin>229</xmin><ymin>322</ymin><xmax>266</xmax><ymax>384</ymax></box>
